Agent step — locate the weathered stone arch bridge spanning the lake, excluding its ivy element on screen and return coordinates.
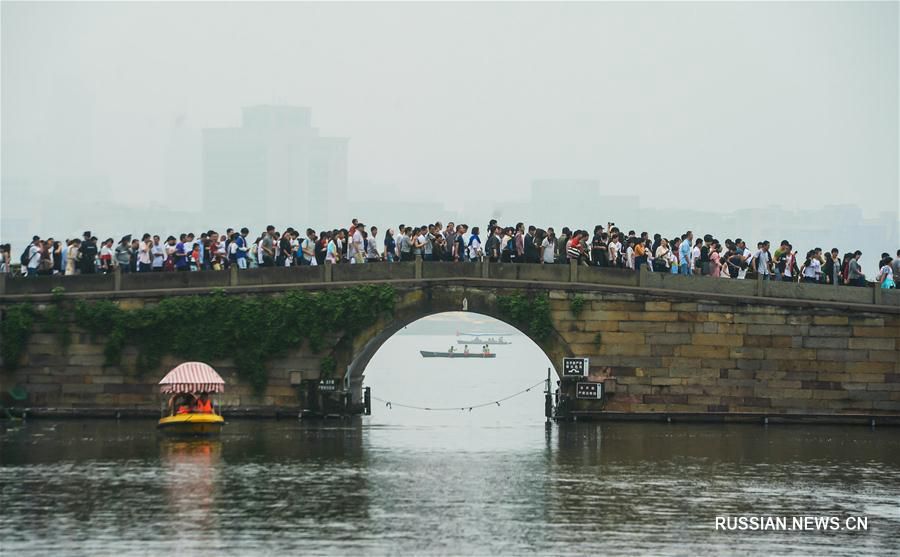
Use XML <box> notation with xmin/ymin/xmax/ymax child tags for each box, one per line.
<box><xmin>0</xmin><ymin>261</ymin><xmax>900</xmax><ymax>423</ymax></box>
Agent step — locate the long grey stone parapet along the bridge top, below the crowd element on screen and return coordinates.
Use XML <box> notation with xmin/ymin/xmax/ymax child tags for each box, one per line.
<box><xmin>0</xmin><ymin>260</ymin><xmax>900</xmax><ymax>307</ymax></box>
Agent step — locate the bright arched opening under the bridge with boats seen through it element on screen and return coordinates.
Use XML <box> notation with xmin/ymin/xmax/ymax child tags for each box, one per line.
<box><xmin>358</xmin><ymin>311</ymin><xmax>557</xmax><ymax>425</ymax></box>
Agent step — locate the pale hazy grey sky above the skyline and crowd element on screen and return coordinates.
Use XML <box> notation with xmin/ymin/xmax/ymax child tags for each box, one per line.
<box><xmin>2</xmin><ymin>1</ymin><xmax>900</xmax><ymax>214</ymax></box>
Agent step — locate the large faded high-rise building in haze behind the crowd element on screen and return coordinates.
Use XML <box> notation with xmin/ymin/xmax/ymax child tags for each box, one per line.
<box><xmin>203</xmin><ymin>105</ymin><xmax>347</xmax><ymax>228</ymax></box>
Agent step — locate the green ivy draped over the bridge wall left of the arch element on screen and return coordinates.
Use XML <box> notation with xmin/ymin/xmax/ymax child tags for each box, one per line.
<box><xmin>2</xmin><ymin>285</ymin><xmax>395</xmax><ymax>393</ymax></box>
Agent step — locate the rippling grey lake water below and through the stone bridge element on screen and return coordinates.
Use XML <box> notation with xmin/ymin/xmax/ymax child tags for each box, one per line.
<box><xmin>0</xmin><ymin>314</ymin><xmax>900</xmax><ymax>556</ymax></box>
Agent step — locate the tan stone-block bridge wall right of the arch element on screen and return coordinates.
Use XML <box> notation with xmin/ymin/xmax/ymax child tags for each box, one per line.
<box><xmin>551</xmin><ymin>291</ymin><xmax>900</xmax><ymax>416</ymax></box>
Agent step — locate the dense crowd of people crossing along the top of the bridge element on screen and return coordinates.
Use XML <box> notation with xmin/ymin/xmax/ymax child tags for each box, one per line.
<box><xmin>0</xmin><ymin>219</ymin><xmax>900</xmax><ymax>288</ymax></box>
